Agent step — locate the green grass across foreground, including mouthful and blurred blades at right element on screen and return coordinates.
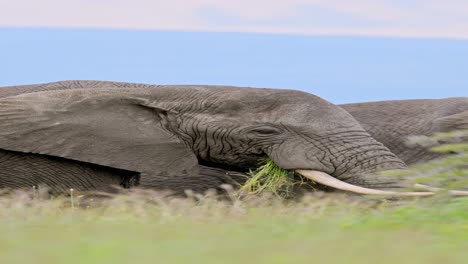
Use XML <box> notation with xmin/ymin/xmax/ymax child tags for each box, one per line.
<box><xmin>0</xmin><ymin>132</ymin><xmax>468</xmax><ymax>264</ymax></box>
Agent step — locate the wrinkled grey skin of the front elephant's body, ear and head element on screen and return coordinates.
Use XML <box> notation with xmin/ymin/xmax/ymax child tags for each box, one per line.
<box><xmin>0</xmin><ymin>81</ymin><xmax>405</xmax><ymax>192</ymax></box>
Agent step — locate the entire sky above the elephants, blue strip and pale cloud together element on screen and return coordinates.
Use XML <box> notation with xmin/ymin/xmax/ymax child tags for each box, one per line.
<box><xmin>0</xmin><ymin>0</ymin><xmax>468</xmax><ymax>103</ymax></box>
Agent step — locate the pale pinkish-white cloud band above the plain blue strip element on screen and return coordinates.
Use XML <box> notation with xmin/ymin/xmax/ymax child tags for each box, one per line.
<box><xmin>0</xmin><ymin>0</ymin><xmax>468</xmax><ymax>39</ymax></box>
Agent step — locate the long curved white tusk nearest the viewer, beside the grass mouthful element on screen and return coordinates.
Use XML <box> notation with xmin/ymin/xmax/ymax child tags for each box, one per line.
<box><xmin>296</xmin><ymin>170</ymin><xmax>434</xmax><ymax>196</ymax></box>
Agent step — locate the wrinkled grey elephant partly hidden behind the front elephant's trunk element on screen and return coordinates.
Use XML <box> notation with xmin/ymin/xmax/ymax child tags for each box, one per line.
<box><xmin>340</xmin><ymin>97</ymin><xmax>468</xmax><ymax>165</ymax></box>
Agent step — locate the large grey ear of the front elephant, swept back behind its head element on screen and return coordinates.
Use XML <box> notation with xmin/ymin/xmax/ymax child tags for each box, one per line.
<box><xmin>0</xmin><ymin>89</ymin><xmax>198</xmax><ymax>183</ymax></box>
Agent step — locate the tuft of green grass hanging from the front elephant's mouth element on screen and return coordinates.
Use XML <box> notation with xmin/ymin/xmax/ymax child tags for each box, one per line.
<box><xmin>240</xmin><ymin>158</ymin><xmax>304</xmax><ymax>197</ymax></box>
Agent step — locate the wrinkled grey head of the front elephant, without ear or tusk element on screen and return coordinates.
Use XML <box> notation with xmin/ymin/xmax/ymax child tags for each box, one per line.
<box><xmin>170</xmin><ymin>87</ymin><xmax>405</xmax><ymax>188</ymax></box>
